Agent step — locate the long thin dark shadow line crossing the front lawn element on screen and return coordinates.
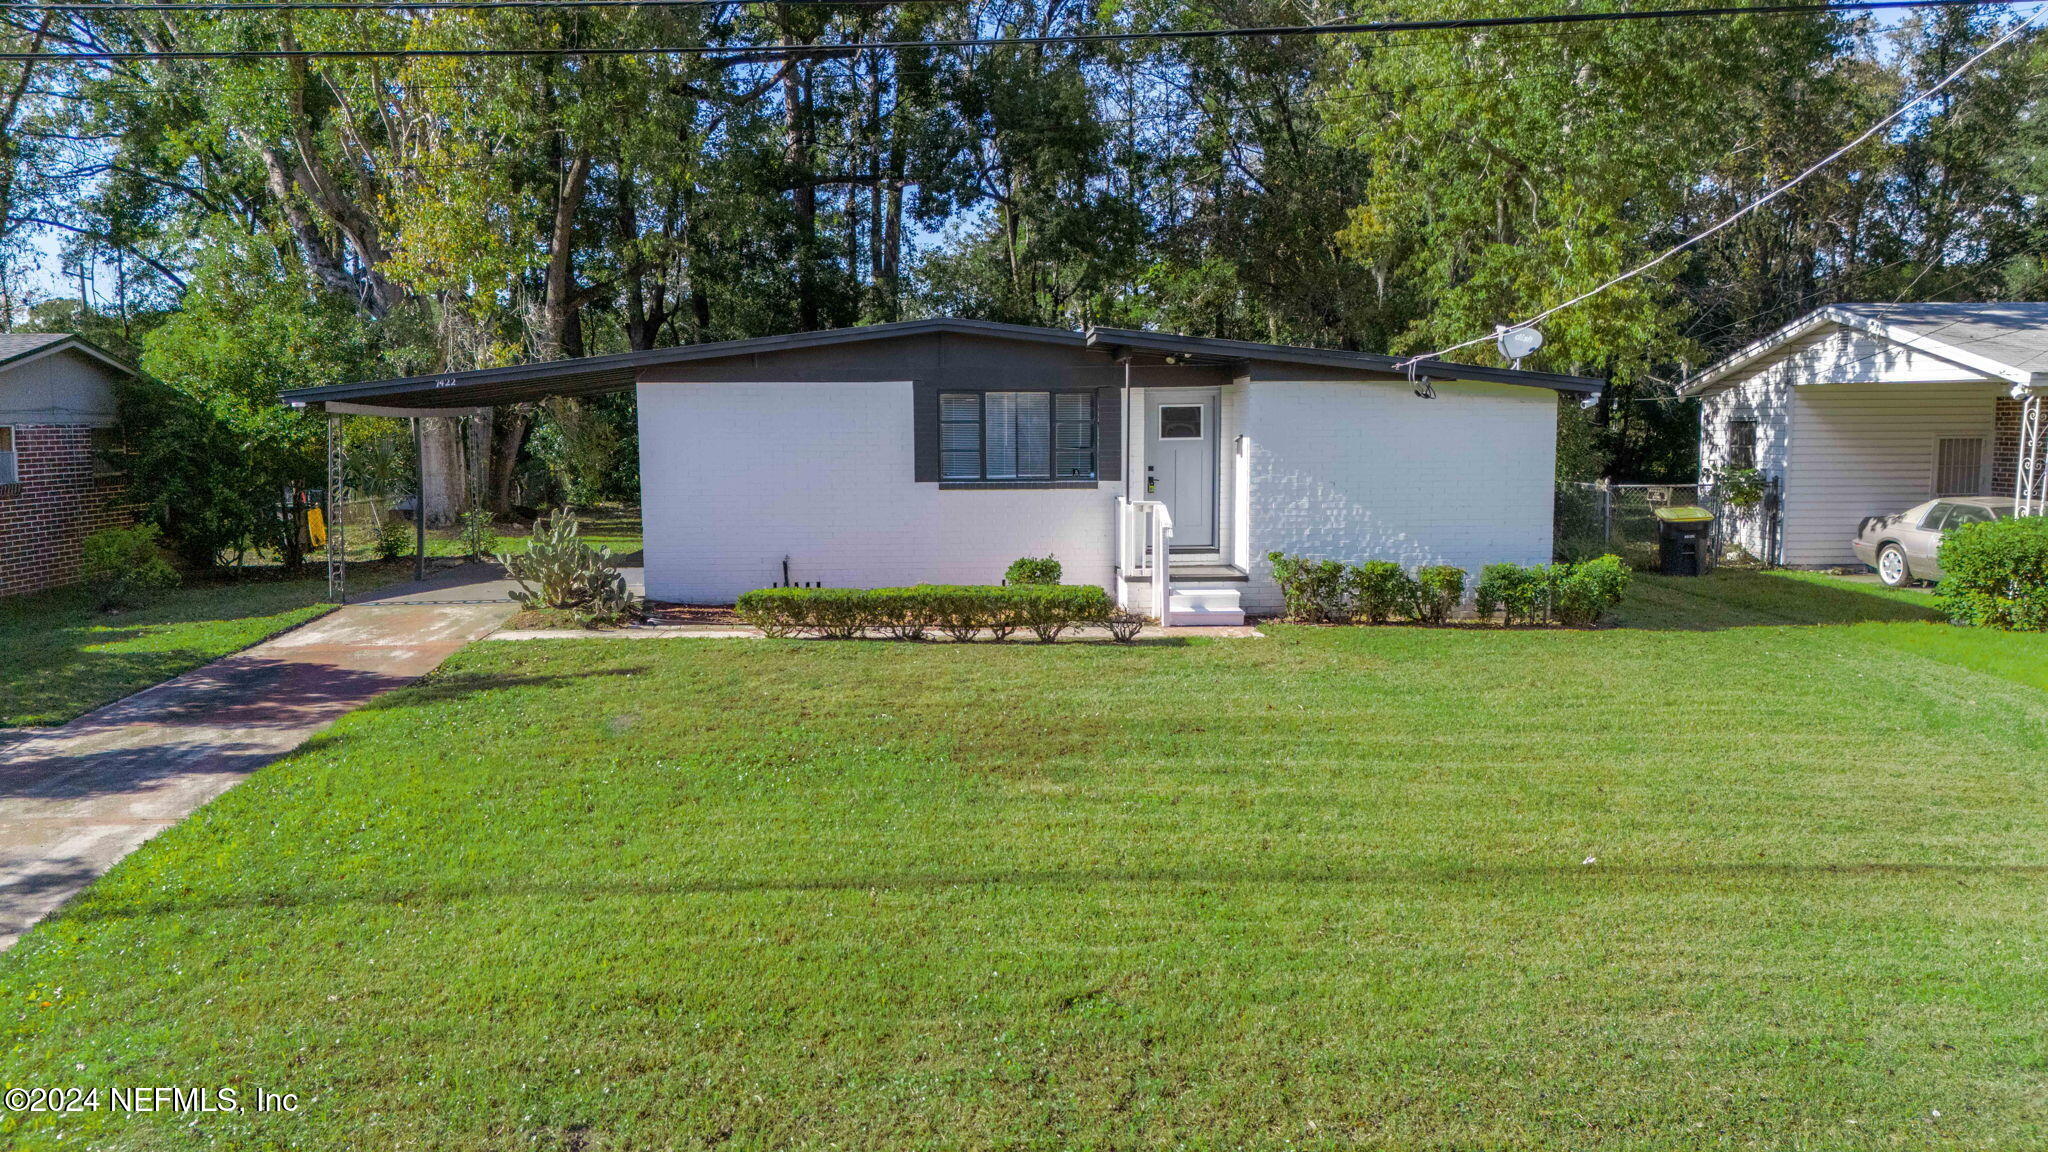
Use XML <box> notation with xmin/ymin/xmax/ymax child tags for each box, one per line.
<box><xmin>51</xmin><ymin>861</ymin><xmax>2048</xmax><ymax>920</ymax></box>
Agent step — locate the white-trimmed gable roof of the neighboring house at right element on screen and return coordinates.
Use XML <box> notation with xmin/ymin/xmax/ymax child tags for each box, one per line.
<box><xmin>1679</xmin><ymin>301</ymin><xmax>2048</xmax><ymax>396</ymax></box>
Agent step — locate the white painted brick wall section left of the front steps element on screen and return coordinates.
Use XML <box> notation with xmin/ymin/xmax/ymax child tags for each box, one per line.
<box><xmin>639</xmin><ymin>381</ymin><xmax>1118</xmax><ymax>603</ymax></box>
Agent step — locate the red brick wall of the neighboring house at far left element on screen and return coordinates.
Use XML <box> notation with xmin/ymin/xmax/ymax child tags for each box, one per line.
<box><xmin>0</xmin><ymin>424</ymin><xmax>129</xmax><ymax>596</ymax></box>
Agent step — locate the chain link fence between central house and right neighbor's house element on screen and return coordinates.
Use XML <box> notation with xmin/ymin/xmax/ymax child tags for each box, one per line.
<box><xmin>1552</xmin><ymin>482</ymin><xmax>1780</xmax><ymax>572</ymax></box>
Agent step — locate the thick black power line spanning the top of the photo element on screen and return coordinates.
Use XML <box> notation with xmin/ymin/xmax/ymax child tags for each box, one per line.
<box><xmin>0</xmin><ymin>0</ymin><xmax>2021</xmax><ymax>64</ymax></box>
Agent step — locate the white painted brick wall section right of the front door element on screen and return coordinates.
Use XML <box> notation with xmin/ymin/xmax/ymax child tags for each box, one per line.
<box><xmin>1241</xmin><ymin>381</ymin><xmax>1556</xmax><ymax>613</ymax></box>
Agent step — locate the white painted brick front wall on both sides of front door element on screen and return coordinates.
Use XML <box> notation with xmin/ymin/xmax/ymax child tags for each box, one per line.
<box><xmin>639</xmin><ymin>381</ymin><xmax>1556</xmax><ymax>611</ymax></box>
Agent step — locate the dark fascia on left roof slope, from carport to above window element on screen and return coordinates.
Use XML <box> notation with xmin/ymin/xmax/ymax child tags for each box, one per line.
<box><xmin>279</xmin><ymin>318</ymin><xmax>1087</xmax><ymax>404</ymax></box>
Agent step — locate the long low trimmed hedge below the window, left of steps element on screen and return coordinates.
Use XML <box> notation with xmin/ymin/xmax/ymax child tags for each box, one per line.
<box><xmin>735</xmin><ymin>584</ymin><xmax>1116</xmax><ymax>644</ymax></box>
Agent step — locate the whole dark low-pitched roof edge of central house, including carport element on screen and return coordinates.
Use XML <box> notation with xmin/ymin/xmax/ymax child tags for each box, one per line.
<box><xmin>279</xmin><ymin>318</ymin><xmax>1604</xmax><ymax>408</ymax></box>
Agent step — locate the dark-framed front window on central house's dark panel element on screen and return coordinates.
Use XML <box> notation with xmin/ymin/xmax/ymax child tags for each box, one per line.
<box><xmin>938</xmin><ymin>392</ymin><xmax>1096</xmax><ymax>484</ymax></box>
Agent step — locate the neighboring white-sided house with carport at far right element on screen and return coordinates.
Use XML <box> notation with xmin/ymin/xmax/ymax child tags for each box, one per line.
<box><xmin>1683</xmin><ymin>303</ymin><xmax>2048</xmax><ymax>568</ymax></box>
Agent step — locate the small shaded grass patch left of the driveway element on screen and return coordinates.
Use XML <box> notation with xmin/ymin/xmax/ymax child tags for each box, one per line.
<box><xmin>0</xmin><ymin>576</ymin><xmax>334</xmax><ymax>728</ymax></box>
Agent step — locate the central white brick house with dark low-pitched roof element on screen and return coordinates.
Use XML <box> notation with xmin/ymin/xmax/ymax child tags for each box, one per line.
<box><xmin>287</xmin><ymin>320</ymin><xmax>1599</xmax><ymax>623</ymax></box>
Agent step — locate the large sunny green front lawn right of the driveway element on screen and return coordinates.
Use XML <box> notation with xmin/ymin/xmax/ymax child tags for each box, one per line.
<box><xmin>0</xmin><ymin>574</ymin><xmax>2048</xmax><ymax>1150</ymax></box>
